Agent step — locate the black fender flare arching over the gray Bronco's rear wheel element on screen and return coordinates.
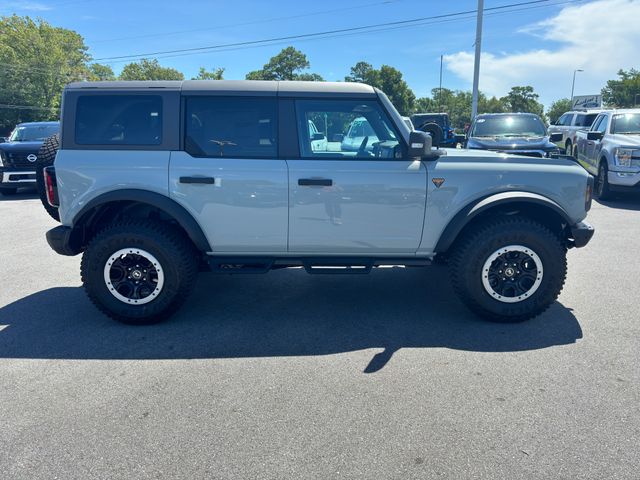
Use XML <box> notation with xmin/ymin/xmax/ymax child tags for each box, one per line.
<box><xmin>72</xmin><ymin>188</ymin><xmax>211</xmax><ymax>252</ymax></box>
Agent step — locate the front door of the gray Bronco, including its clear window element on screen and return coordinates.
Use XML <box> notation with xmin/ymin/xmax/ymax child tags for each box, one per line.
<box><xmin>288</xmin><ymin>100</ymin><xmax>427</xmax><ymax>256</ymax></box>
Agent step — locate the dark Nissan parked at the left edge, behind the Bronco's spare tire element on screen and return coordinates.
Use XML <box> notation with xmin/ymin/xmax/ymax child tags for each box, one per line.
<box><xmin>0</xmin><ymin>122</ymin><xmax>60</xmax><ymax>195</ymax></box>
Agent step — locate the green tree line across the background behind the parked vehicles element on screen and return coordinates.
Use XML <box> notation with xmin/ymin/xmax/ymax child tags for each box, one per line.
<box><xmin>0</xmin><ymin>15</ymin><xmax>640</xmax><ymax>132</ymax></box>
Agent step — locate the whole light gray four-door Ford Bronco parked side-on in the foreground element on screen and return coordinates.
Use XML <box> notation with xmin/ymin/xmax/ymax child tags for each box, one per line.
<box><xmin>44</xmin><ymin>81</ymin><xmax>593</xmax><ymax>324</ymax></box>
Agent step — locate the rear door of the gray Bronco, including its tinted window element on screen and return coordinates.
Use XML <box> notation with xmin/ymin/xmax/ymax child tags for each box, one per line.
<box><xmin>169</xmin><ymin>91</ymin><xmax>288</xmax><ymax>254</ymax></box>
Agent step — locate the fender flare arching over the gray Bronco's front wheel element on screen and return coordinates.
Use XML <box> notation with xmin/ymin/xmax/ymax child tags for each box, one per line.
<box><xmin>434</xmin><ymin>191</ymin><xmax>573</xmax><ymax>253</ymax></box>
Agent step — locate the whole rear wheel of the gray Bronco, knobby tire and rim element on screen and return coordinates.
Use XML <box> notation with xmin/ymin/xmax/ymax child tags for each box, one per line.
<box><xmin>80</xmin><ymin>221</ymin><xmax>198</xmax><ymax>325</ymax></box>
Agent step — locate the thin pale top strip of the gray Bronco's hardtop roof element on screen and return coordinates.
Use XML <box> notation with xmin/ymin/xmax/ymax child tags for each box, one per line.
<box><xmin>65</xmin><ymin>80</ymin><xmax>376</xmax><ymax>96</ymax></box>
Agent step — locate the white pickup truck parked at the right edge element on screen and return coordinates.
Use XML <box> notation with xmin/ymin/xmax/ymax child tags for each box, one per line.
<box><xmin>576</xmin><ymin>108</ymin><xmax>640</xmax><ymax>200</ymax></box>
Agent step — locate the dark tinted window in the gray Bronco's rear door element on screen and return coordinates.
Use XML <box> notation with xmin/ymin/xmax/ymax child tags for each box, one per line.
<box><xmin>184</xmin><ymin>97</ymin><xmax>276</xmax><ymax>158</ymax></box>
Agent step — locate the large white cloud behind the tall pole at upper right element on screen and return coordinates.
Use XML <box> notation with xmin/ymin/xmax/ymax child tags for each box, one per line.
<box><xmin>444</xmin><ymin>0</ymin><xmax>640</xmax><ymax>105</ymax></box>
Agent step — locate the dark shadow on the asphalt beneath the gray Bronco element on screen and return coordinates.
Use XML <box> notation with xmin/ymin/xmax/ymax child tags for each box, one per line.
<box><xmin>0</xmin><ymin>266</ymin><xmax>582</xmax><ymax>373</ymax></box>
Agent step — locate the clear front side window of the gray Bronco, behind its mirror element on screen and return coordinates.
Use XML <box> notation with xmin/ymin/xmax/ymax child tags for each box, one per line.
<box><xmin>296</xmin><ymin>100</ymin><xmax>402</xmax><ymax>160</ymax></box>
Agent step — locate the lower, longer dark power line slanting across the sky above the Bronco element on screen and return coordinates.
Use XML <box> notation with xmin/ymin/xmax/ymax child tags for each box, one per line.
<box><xmin>95</xmin><ymin>0</ymin><xmax>551</xmax><ymax>61</ymax></box>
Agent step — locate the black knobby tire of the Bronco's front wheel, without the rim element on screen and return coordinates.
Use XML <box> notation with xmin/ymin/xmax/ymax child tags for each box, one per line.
<box><xmin>450</xmin><ymin>216</ymin><xmax>567</xmax><ymax>323</ymax></box>
